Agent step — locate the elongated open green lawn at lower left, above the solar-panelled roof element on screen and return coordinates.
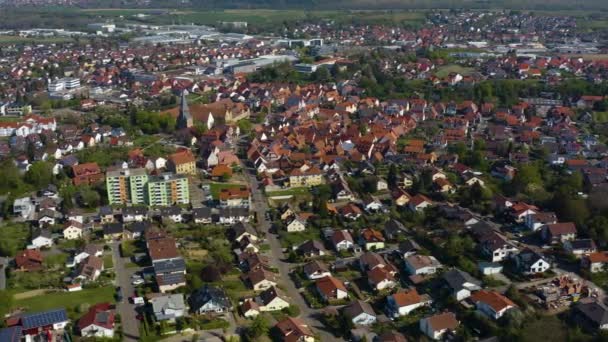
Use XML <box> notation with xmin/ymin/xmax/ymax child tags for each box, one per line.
<box><xmin>13</xmin><ymin>287</ymin><xmax>114</xmax><ymax>312</ymax></box>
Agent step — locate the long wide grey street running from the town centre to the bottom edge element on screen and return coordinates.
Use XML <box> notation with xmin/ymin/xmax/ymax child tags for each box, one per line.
<box><xmin>246</xmin><ymin>172</ymin><xmax>343</xmax><ymax>341</ymax></box>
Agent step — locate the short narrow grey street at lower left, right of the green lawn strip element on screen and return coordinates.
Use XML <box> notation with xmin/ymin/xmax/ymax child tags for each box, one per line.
<box><xmin>112</xmin><ymin>242</ymin><xmax>139</xmax><ymax>341</ymax></box>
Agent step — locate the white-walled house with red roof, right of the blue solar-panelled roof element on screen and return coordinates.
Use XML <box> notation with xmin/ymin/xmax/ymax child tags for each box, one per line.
<box><xmin>77</xmin><ymin>303</ymin><xmax>116</xmax><ymax>338</ymax></box>
